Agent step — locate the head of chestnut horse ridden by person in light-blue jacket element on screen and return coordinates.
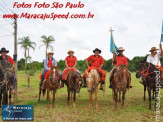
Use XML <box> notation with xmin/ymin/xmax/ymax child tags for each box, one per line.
<box><xmin>49</xmin><ymin>66</ymin><xmax>58</xmax><ymax>85</ymax></box>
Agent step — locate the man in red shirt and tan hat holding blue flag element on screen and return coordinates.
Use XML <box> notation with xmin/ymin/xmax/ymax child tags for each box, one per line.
<box><xmin>109</xmin><ymin>47</ymin><xmax>131</xmax><ymax>88</ymax></box>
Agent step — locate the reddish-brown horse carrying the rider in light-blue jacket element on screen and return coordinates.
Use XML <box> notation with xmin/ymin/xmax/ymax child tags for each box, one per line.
<box><xmin>38</xmin><ymin>66</ymin><xmax>58</xmax><ymax>109</ymax></box>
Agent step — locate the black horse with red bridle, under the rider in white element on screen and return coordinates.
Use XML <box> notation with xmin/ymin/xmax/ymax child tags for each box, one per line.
<box><xmin>136</xmin><ymin>62</ymin><xmax>159</xmax><ymax>109</ymax></box>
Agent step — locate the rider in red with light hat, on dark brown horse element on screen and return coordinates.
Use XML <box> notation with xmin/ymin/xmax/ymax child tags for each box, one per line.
<box><xmin>61</xmin><ymin>50</ymin><xmax>80</xmax><ymax>88</ymax></box>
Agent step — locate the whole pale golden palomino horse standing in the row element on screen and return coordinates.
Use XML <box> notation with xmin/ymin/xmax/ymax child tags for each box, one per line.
<box><xmin>86</xmin><ymin>69</ymin><xmax>100</xmax><ymax>110</ymax></box>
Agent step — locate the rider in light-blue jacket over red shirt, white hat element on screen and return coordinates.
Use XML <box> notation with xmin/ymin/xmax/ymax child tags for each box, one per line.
<box><xmin>41</xmin><ymin>51</ymin><xmax>57</xmax><ymax>89</ymax></box>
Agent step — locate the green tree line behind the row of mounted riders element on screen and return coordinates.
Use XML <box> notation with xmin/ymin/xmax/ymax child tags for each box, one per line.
<box><xmin>18</xmin><ymin>55</ymin><xmax>163</xmax><ymax>72</ymax></box>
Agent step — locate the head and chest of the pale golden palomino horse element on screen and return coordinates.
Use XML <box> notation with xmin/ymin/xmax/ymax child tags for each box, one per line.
<box><xmin>86</xmin><ymin>69</ymin><xmax>99</xmax><ymax>92</ymax></box>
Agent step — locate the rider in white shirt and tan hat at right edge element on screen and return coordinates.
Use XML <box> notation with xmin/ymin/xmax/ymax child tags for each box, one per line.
<box><xmin>145</xmin><ymin>44</ymin><xmax>163</xmax><ymax>86</ymax></box>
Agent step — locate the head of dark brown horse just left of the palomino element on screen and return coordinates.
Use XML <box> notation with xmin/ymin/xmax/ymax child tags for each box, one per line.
<box><xmin>75</xmin><ymin>74</ymin><xmax>83</xmax><ymax>93</ymax></box>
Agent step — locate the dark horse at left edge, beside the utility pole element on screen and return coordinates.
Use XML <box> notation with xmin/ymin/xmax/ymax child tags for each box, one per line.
<box><xmin>0</xmin><ymin>60</ymin><xmax>15</xmax><ymax>108</ymax></box>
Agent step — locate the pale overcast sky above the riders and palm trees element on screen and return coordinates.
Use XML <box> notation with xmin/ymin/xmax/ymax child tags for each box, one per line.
<box><xmin>0</xmin><ymin>0</ymin><xmax>163</xmax><ymax>61</ymax></box>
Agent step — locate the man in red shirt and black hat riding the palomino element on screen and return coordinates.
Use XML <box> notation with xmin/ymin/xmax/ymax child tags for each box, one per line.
<box><xmin>84</xmin><ymin>48</ymin><xmax>106</xmax><ymax>90</ymax></box>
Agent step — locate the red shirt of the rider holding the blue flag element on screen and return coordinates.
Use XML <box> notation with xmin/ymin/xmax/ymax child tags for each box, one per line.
<box><xmin>114</xmin><ymin>55</ymin><xmax>128</xmax><ymax>66</ymax></box>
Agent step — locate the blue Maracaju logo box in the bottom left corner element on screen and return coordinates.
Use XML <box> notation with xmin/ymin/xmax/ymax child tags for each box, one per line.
<box><xmin>2</xmin><ymin>105</ymin><xmax>33</xmax><ymax>121</ymax></box>
